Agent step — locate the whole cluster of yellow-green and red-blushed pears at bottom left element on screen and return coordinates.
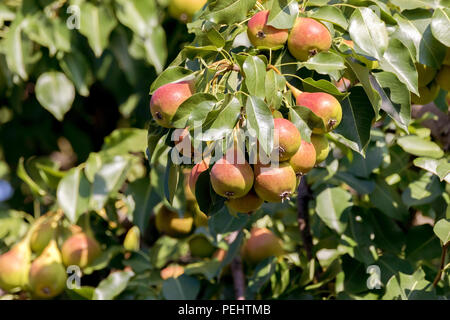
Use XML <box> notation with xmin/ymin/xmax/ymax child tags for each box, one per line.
<box><xmin>0</xmin><ymin>213</ymin><xmax>100</xmax><ymax>299</ymax></box>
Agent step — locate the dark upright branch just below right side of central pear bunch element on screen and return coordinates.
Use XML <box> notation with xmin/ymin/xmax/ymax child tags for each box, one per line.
<box><xmin>297</xmin><ymin>176</ymin><xmax>313</xmax><ymax>260</ymax></box>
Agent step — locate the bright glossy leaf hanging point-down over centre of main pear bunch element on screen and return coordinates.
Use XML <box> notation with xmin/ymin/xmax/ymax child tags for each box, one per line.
<box><xmin>245</xmin><ymin>94</ymin><xmax>274</xmax><ymax>155</ymax></box>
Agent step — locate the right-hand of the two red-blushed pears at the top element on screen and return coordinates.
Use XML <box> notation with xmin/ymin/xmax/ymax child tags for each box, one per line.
<box><xmin>288</xmin><ymin>17</ymin><xmax>331</xmax><ymax>61</ymax></box>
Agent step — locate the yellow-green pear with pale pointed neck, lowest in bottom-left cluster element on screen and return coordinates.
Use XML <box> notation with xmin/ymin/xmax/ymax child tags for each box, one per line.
<box><xmin>29</xmin><ymin>240</ymin><xmax>67</xmax><ymax>299</ymax></box>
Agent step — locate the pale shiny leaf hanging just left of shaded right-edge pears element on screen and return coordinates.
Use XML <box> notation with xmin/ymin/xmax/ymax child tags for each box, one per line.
<box><xmin>379</xmin><ymin>38</ymin><xmax>418</xmax><ymax>94</ymax></box>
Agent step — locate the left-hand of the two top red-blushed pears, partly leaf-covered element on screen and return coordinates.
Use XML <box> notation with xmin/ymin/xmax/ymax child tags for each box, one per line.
<box><xmin>247</xmin><ymin>10</ymin><xmax>289</xmax><ymax>48</ymax></box>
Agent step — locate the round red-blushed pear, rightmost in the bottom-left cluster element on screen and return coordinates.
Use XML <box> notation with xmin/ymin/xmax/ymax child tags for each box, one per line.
<box><xmin>61</xmin><ymin>232</ymin><xmax>101</xmax><ymax>268</ymax></box>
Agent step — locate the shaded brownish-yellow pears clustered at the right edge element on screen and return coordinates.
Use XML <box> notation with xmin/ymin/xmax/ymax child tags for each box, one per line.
<box><xmin>411</xmin><ymin>48</ymin><xmax>450</xmax><ymax>105</ymax></box>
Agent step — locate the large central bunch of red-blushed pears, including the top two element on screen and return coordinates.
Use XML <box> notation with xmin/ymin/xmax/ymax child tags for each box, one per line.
<box><xmin>150</xmin><ymin>11</ymin><xmax>342</xmax><ymax>213</ymax></box>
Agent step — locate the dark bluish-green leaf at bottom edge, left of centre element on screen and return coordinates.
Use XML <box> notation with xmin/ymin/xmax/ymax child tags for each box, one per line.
<box><xmin>162</xmin><ymin>274</ymin><xmax>200</xmax><ymax>300</ymax></box>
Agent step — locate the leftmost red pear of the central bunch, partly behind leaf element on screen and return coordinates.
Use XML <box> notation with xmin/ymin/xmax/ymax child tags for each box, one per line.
<box><xmin>150</xmin><ymin>81</ymin><xmax>194</xmax><ymax>128</ymax></box>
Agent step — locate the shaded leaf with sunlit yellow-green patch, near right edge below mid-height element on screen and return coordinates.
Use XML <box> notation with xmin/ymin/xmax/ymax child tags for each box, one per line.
<box><xmin>402</xmin><ymin>172</ymin><xmax>443</xmax><ymax>207</ymax></box>
